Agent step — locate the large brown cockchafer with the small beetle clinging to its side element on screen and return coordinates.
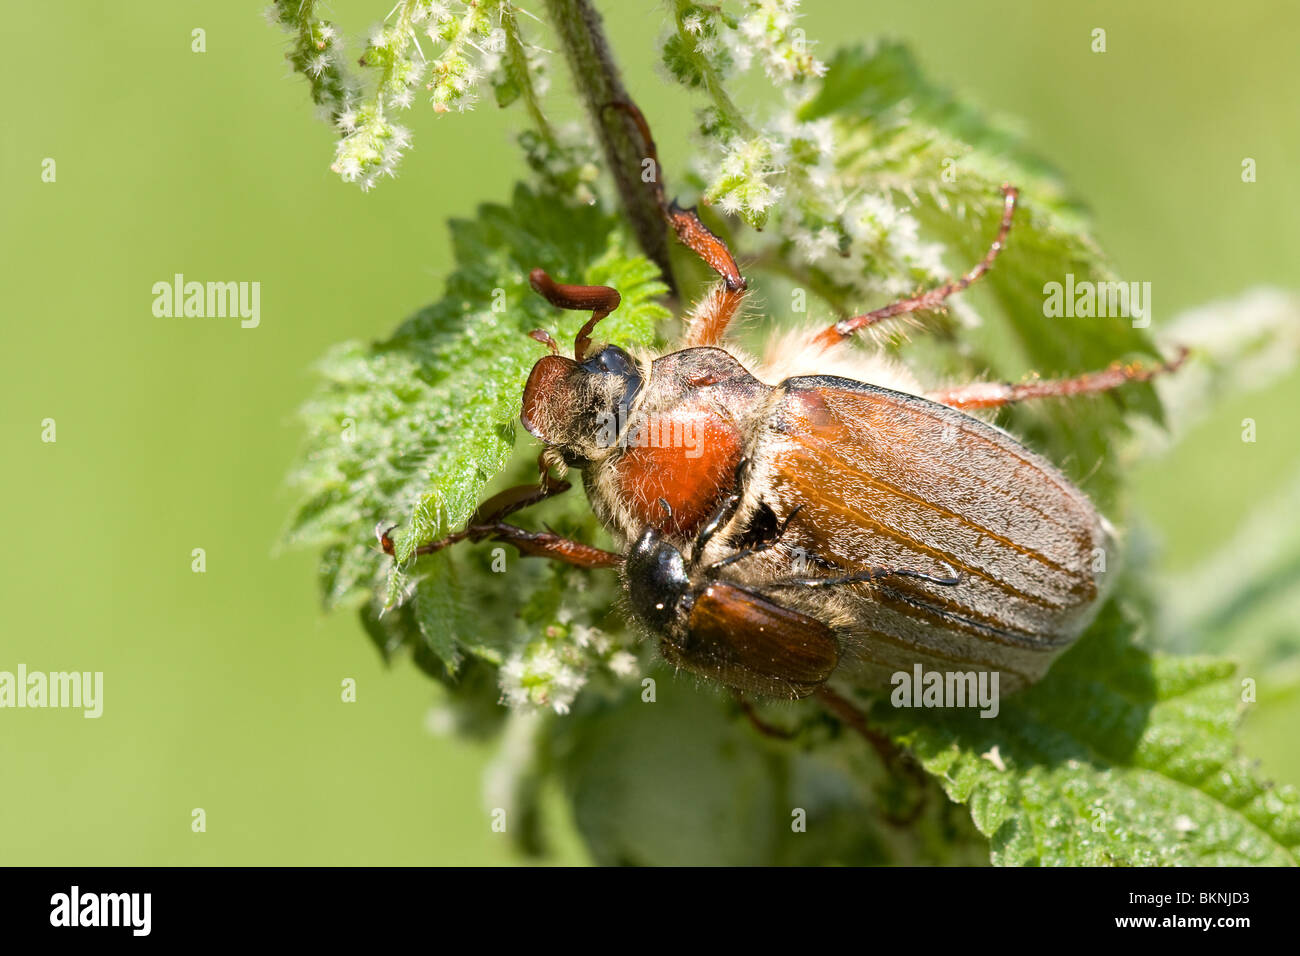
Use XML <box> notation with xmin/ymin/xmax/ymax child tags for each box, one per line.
<box><xmin>381</xmin><ymin>104</ymin><xmax>1186</xmax><ymax>697</ymax></box>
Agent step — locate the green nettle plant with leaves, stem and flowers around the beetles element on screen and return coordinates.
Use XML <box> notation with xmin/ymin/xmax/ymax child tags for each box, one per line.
<box><xmin>272</xmin><ymin>0</ymin><xmax>1300</xmax><ymax>865</ymax></box>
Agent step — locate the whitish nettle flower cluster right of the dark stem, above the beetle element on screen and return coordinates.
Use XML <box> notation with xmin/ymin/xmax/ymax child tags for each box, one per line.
<box><xmin>663</xmin><ymin>0</ymin><xmax>945</xmax><ymax>299</ymax></box>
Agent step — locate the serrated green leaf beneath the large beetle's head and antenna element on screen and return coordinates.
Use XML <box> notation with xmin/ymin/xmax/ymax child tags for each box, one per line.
<box><xmin>286</xmin><ymin>187</ymin><xmax>666</xmax><ymax>647</ymax></box>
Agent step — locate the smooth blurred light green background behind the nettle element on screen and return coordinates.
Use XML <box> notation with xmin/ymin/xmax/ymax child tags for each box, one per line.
<box><xmin>0</xmin><ymin>0</ymin><xmax>1300</xmax><ymax>865</ymax></box>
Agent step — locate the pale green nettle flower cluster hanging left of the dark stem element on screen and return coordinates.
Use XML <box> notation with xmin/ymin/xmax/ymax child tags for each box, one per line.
<box><xmin>269</xmin><ymin>0</ymin><xmax>545</xmax><ymax>190</ymax></box>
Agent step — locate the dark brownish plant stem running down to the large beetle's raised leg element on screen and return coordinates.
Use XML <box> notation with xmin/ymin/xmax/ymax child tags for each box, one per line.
<box><xmin>546</xmin><ymin>0</ymin><xmax>676</xmax><ymax>289</ymax></box>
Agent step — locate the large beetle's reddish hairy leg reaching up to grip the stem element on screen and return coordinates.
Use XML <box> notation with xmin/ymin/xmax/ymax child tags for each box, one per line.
<box><xmin>605</xmin><ymin>100</ymin><xmax>748</xmax><ymax>346</ymax></box>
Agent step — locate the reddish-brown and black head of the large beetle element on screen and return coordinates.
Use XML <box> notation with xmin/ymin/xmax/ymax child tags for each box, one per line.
<box><xmin>520</xmin><ymin>345</ymin><xmax>641</xmax><ymax>466</ymax></box>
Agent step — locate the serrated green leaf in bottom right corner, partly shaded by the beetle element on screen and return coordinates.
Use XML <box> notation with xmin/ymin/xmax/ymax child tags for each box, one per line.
<box><xmin>874</xmin><ymin>602</ymin><xmax>1300</xmax><ymax>866</ymax></box>
